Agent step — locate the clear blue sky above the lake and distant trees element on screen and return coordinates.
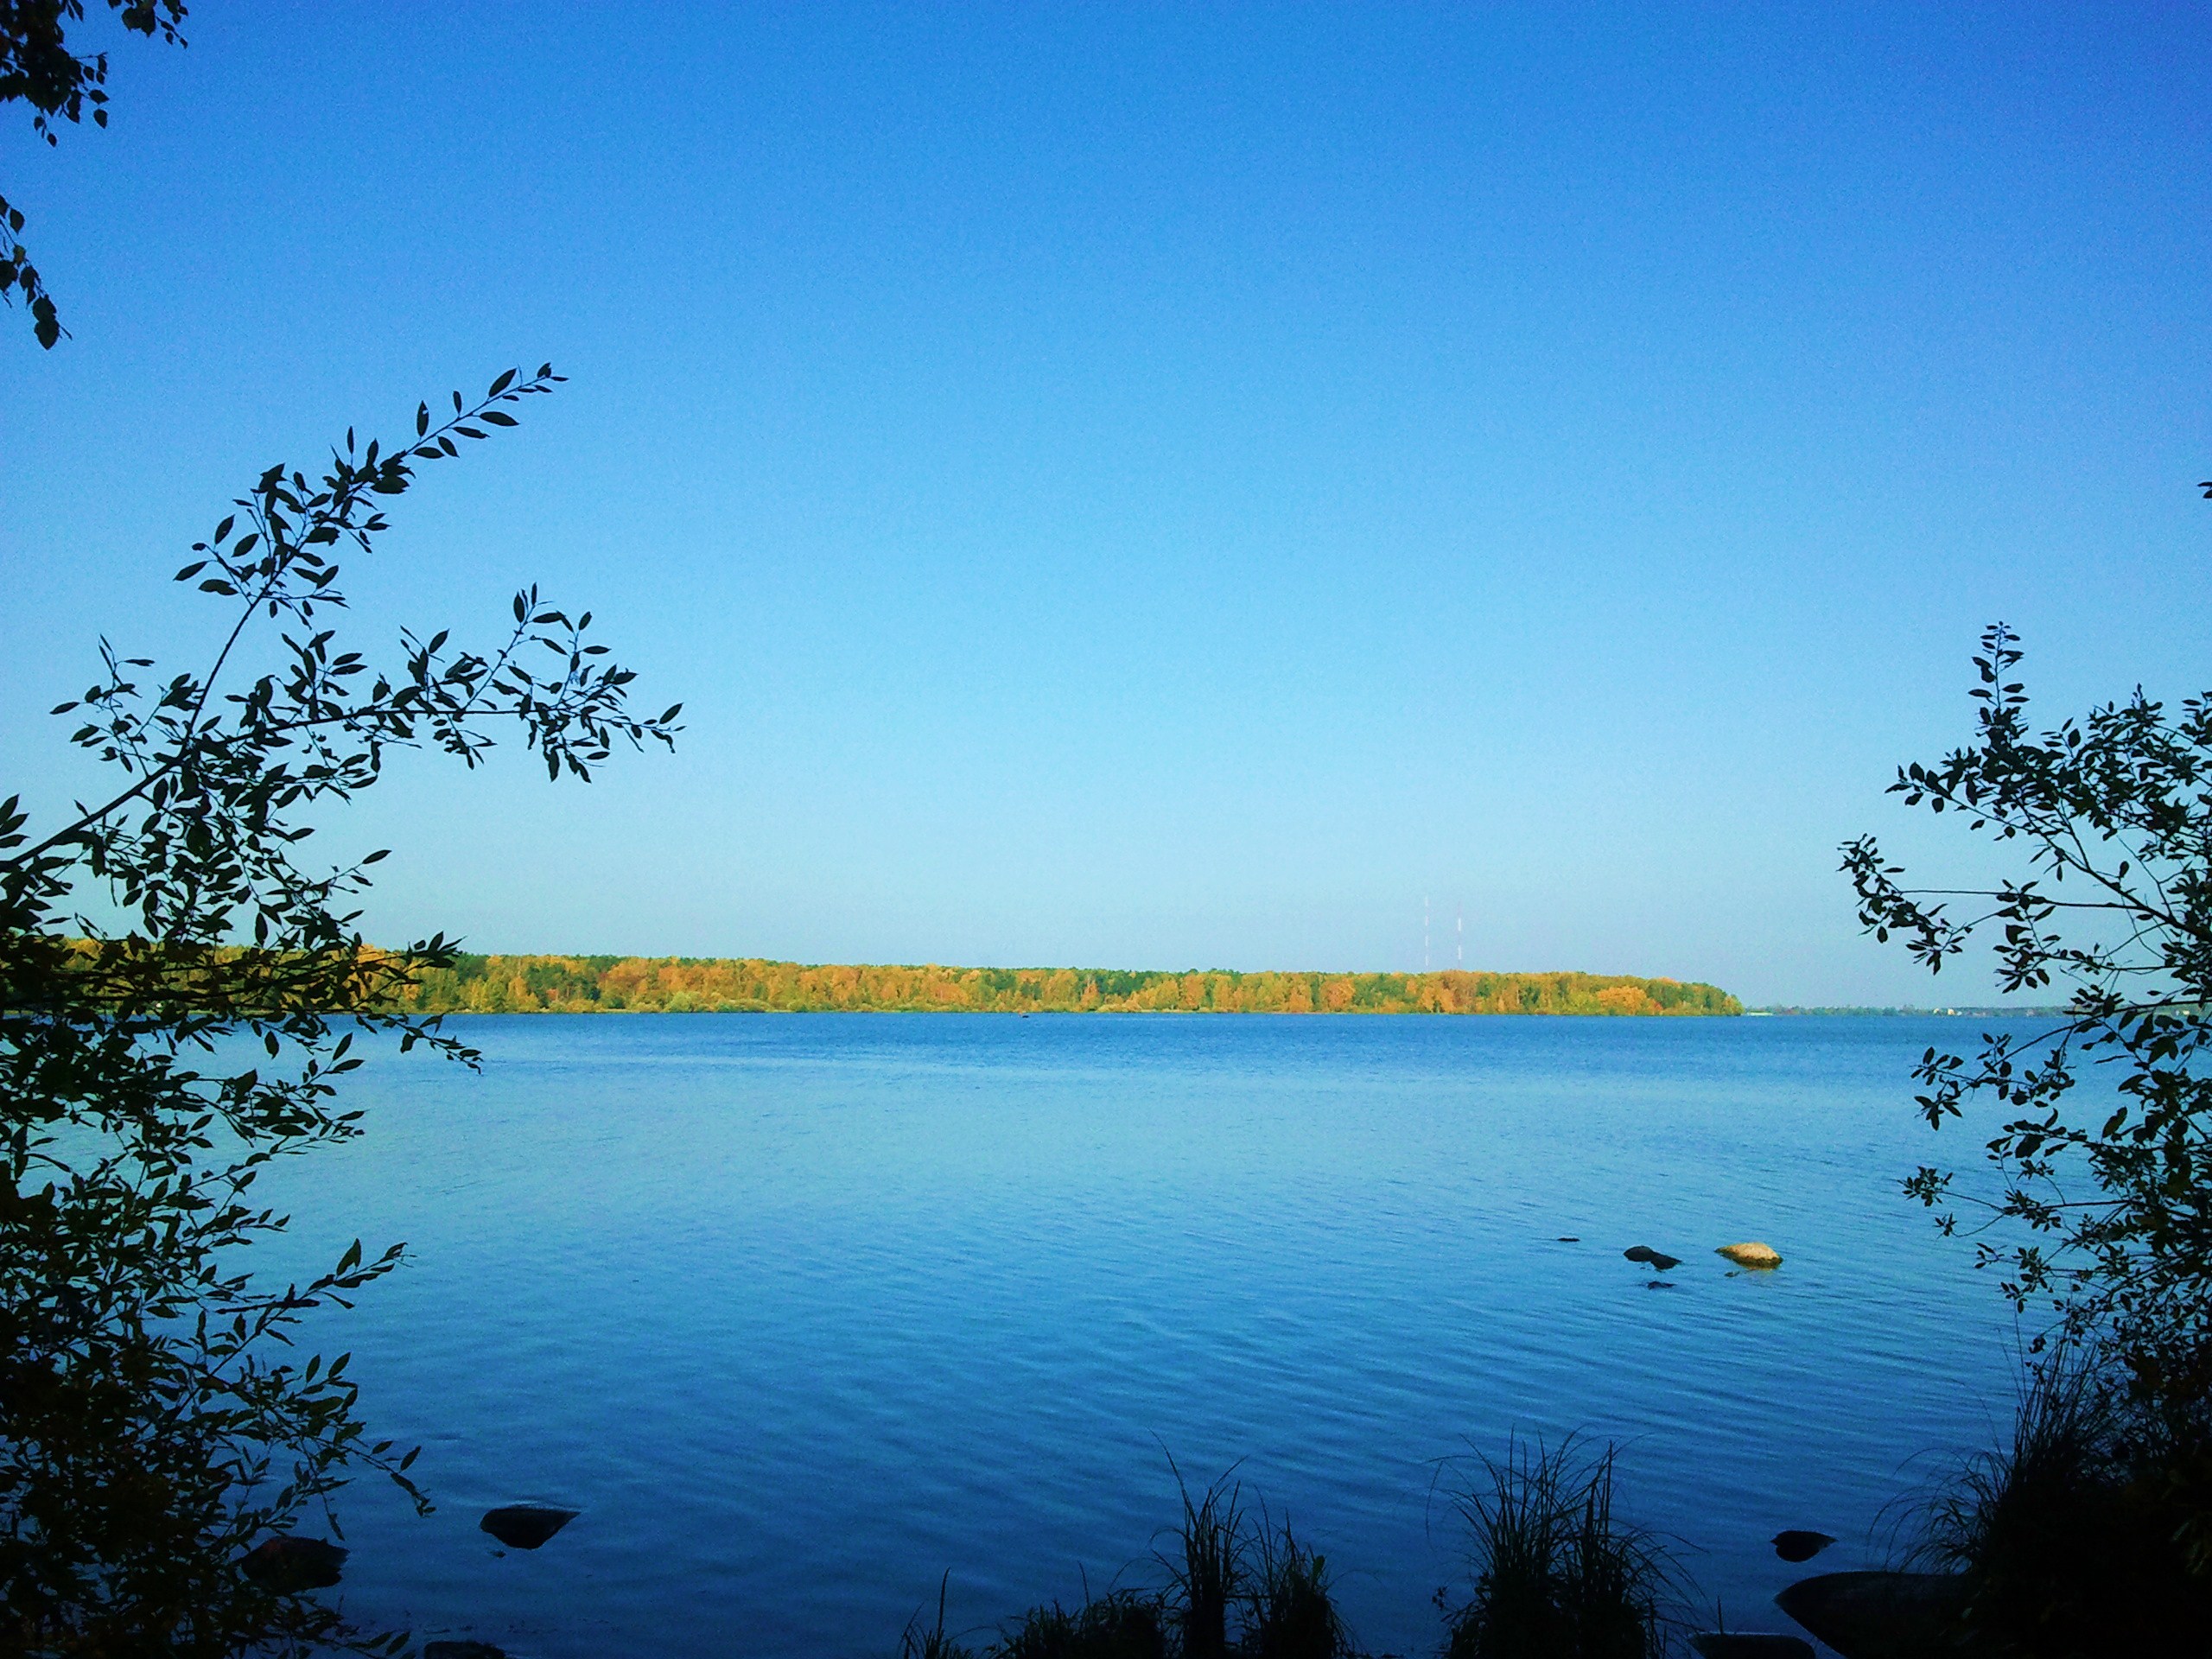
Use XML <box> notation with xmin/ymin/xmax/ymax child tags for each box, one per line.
<box><xmin>0</xmin><ymin>0</ymin><xmax>2212</xmax><ymax>1002</ymax></box>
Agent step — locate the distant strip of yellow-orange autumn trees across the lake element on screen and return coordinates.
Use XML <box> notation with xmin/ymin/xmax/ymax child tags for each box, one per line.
<box><xmin>403</xmin><ymin>953</ymin><xmax>1743</xmax><ymax>1015</ymax></box>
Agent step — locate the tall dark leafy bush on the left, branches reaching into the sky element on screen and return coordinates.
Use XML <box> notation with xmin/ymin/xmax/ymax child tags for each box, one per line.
<box><xmin>0</xmin><ymin>367</ymin><xmax>677</xmax><ymax>1655</ymax></box>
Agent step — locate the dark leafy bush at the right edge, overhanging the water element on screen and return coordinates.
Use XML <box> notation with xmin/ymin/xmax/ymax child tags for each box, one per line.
<box><xmin>1842</xmin><ymin>626</ymin><xmax>2212</xmax><ymax>1421</ymax></box>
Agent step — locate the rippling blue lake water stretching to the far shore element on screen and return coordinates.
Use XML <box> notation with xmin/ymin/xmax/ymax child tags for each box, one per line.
<box><xmin>285</xmin><ymin>1015</ymin><xmax>2044</xmax><ymax>1659</ymax></box>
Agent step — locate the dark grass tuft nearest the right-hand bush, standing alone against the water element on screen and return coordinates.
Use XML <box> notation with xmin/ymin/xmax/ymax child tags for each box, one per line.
<box><xmin>1446</xmin><ymin>1435</ymin><xmax>1675</xmax><ymax>1659</ymax></box>
